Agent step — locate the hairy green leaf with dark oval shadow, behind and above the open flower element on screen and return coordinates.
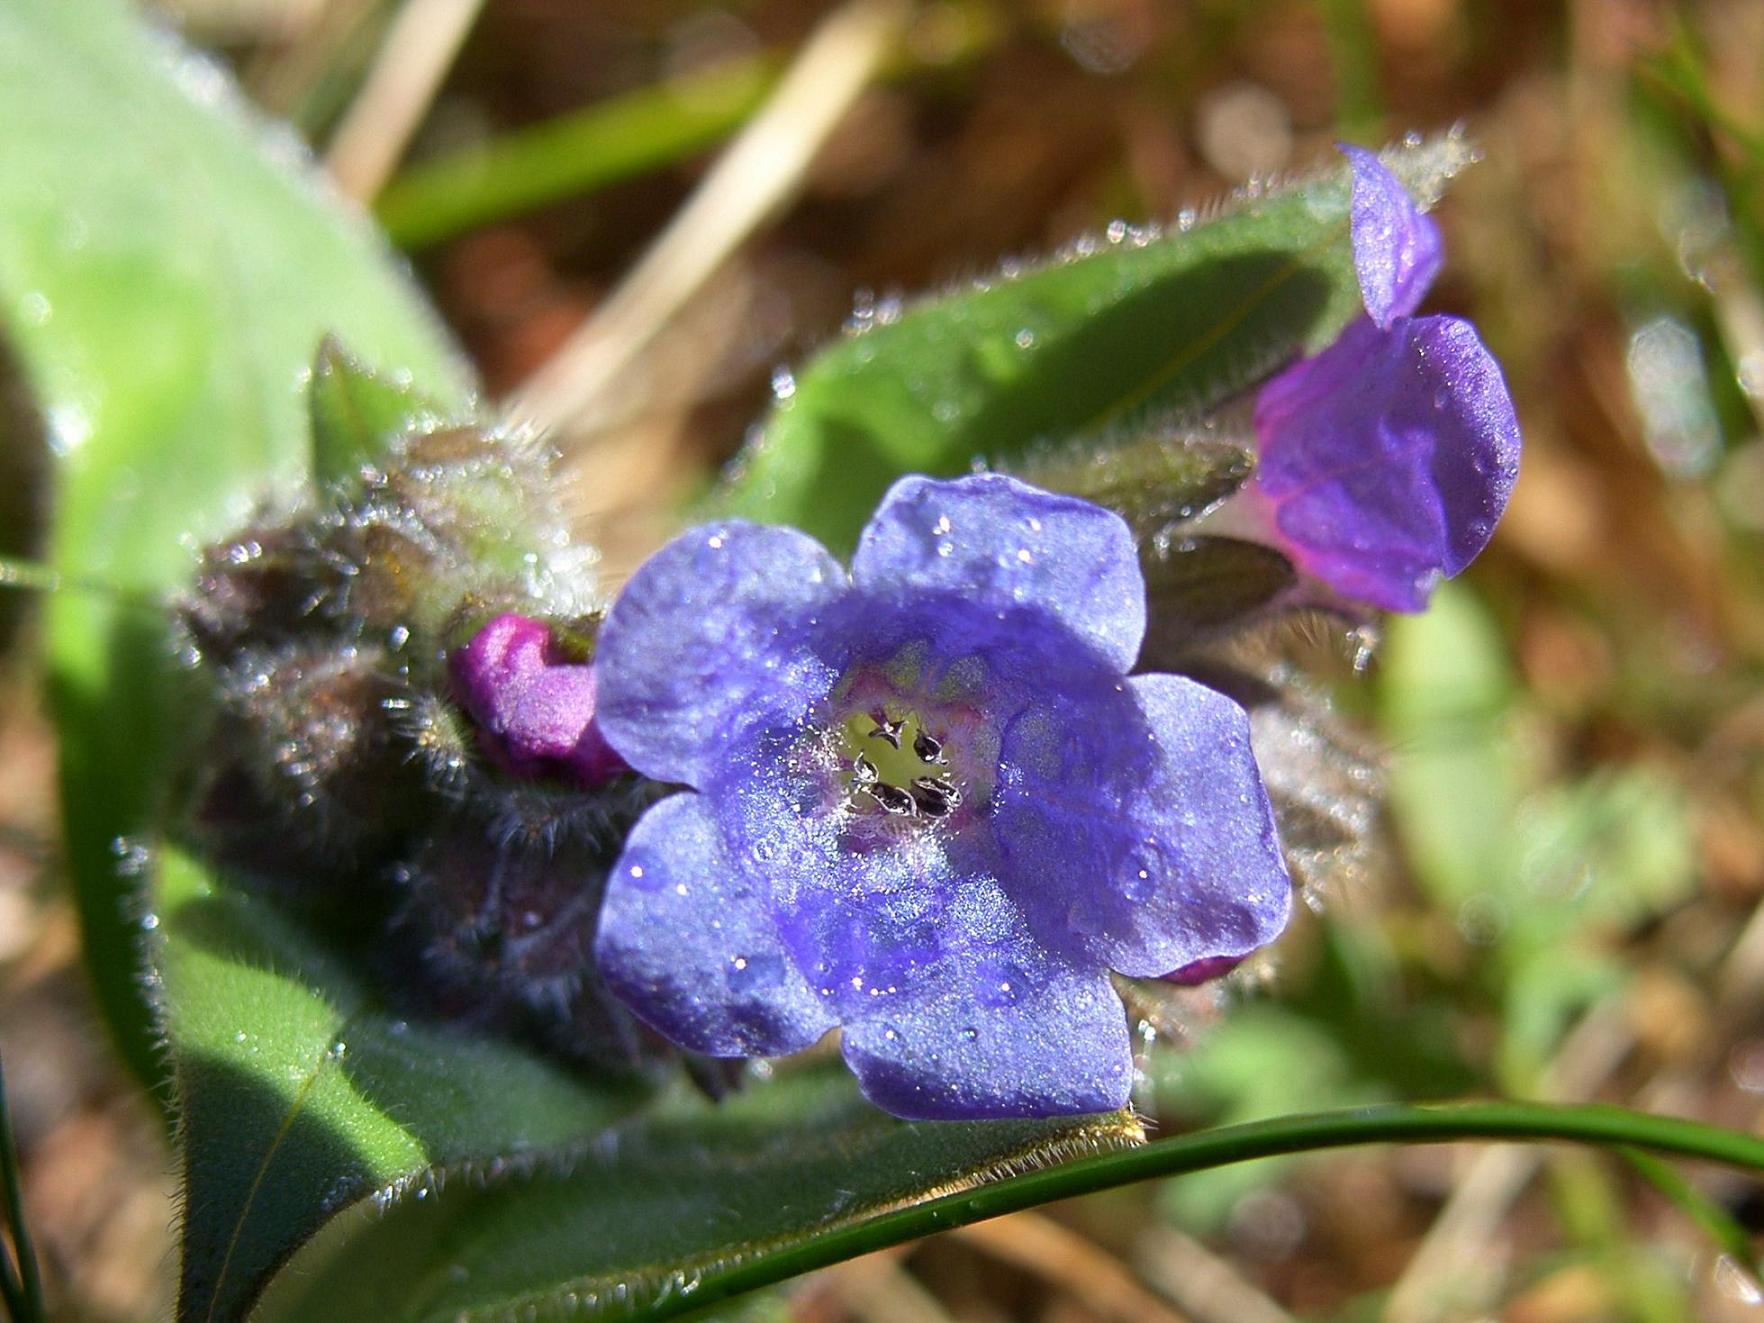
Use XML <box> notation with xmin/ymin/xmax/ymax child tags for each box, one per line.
<box><xmin>721</xmin><ymin>138</ymin><xmax>1471</xmax><ymax>549</ymax></box>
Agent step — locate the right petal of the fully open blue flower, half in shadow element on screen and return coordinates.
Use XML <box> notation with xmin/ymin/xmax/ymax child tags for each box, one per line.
<box><xmin>995</xmin><ymin>676</ymin><xmax>1291</xmax><ymax>977</ymax></box>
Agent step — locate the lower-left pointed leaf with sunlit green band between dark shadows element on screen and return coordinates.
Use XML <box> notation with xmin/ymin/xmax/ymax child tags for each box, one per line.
<box><xmin>157</xmin><ymin>847</ymin><xmax>642</xmax><ymax>1319</ymax></box>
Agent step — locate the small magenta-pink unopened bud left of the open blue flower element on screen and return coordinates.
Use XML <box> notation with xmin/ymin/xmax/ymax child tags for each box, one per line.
<box><xmin>448</xmin><ymin>614</ymin><xmax>628</xmax><ymax>787</ymax></box>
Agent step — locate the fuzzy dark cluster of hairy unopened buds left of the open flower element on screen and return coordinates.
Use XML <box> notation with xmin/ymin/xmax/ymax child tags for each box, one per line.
<box><xmin>178</xmin><ymin>365</ymin><xmax>660</xmax><ymax>1069</ymax></box>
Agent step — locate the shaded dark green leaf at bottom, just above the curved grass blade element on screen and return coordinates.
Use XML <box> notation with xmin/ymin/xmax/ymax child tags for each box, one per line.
<box><xmin>261</xmin><ymin>1067</ymin><xmax>1141</xmax><ymax>1323</ymax></box>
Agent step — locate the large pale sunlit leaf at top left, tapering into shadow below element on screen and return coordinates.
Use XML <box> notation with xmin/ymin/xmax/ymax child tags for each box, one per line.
<box><xmin>0</xmin><ymin>0</ymin><xmax>473</xmax><ymax>1080</ymax></box>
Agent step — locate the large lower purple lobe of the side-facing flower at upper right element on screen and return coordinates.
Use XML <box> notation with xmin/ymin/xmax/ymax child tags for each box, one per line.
<box><xmin>1254</xmin><ymin>318</ymin><xmax>1519</xmax><ymax>610</ymax></box>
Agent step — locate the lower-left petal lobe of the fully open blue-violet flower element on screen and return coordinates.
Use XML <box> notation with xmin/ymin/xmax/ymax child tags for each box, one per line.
<box><xmin>594</xmin><ymin>792</ymin><xmax>834</xmax><ymax>1057</ymax></box>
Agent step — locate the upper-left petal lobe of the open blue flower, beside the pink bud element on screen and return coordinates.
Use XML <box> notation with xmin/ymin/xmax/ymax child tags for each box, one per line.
<box><xmin>594</xmin><ymin>522</ymin><xmax>848</xmax><ymax>787</ymax></box>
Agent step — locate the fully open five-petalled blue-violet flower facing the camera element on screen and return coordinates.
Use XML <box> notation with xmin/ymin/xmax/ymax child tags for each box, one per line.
<box><xmin>596</xmin><ymin>475</ymin><xmax>1291</xmax><ymax>1118</ymax></box>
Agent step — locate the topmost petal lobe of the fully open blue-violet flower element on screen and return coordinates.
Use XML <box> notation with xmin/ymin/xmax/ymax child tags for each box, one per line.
<box><xmin>852</xmin><ymin>473</ymin><xmax>1145</xmax><ymax>672</ymax></box>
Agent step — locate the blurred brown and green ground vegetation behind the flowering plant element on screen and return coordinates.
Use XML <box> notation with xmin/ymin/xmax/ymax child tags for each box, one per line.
<box><xmin>0</xmin><ymin>0</ymin><xmax>1764</xmax><ymax>1323</ymax></box>
